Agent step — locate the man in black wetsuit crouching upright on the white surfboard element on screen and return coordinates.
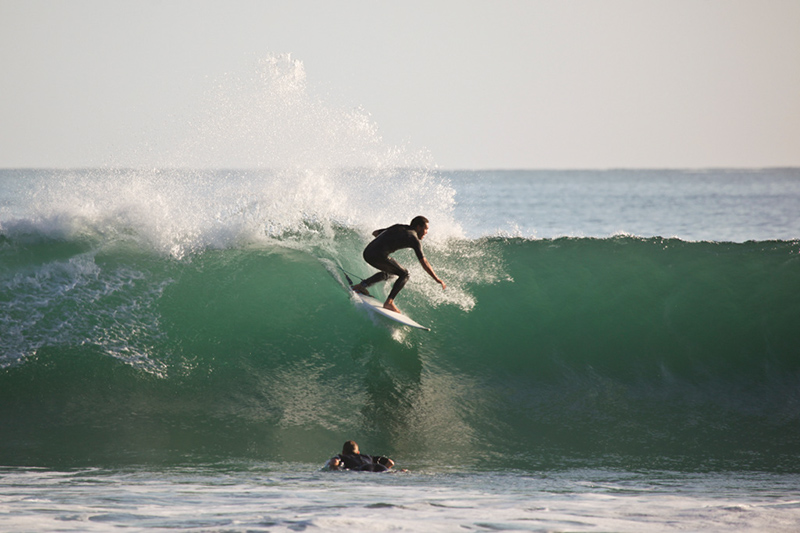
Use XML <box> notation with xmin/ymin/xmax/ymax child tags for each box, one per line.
<box><xmin>352</xmin><ymin>216</ymin><xmax>447</xmax><ymax>313</ymax></box>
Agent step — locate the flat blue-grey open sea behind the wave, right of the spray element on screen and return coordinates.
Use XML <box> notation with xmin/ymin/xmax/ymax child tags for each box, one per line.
<box><xmin>448</xmin><ymin>169</ymin><xmax>800</xmax><ymax>242</ymax></box>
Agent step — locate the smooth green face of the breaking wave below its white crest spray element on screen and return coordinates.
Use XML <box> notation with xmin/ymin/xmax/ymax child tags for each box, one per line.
<box><xmin>0</xmin><ymin>229</ymin><xmax>800</xmax><ymax>470</ymax></box>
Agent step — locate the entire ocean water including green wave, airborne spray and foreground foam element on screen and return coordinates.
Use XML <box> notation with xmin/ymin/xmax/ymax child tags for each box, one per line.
<box><xmin>0</xmin><ymin>57</ymin><xmax>800</xmax><ymax>532</ymax></box>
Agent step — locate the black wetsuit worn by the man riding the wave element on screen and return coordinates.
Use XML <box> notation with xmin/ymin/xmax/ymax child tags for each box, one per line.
<box><xmin>362</xmin><ymin>224</ymin><xmax>425</xmax><ymax>300</ymax></box>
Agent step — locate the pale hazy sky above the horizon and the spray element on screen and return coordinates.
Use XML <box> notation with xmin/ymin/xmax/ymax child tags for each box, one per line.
<box><xmin>0</xmin><ymin>0</ymin><xmax>800</xmax><ymax>168</ymax></box>
